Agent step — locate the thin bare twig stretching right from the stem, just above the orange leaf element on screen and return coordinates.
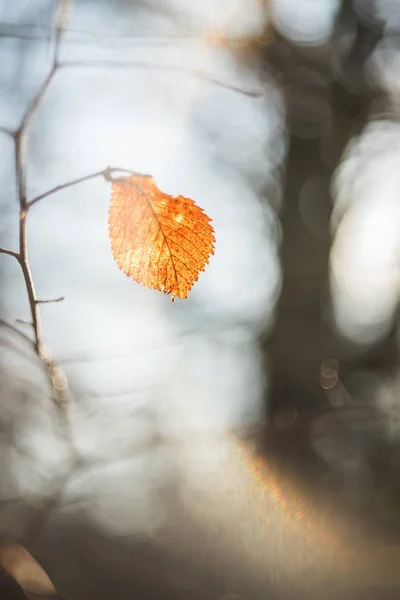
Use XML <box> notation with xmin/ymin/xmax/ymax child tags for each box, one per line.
<box><xmin>60</xmin><ymin>60</ymin><xmax>264</xmax><ymax>98</ymax></box>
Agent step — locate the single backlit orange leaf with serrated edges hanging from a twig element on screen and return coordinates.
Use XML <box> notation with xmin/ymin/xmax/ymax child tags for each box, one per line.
<box><xmin>108</xmin><ymin>175</ymin><xmax>215</xmax><ymax>300</ymax></box>
